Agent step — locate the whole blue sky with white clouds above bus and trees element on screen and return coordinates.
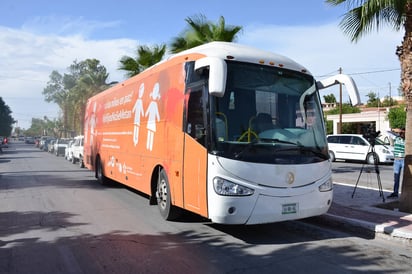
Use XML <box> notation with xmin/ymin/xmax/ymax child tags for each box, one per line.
<box><xmin>0</xmin><ymin>0</ymin><xmax>403</xmax><ymax>129</ymax></box>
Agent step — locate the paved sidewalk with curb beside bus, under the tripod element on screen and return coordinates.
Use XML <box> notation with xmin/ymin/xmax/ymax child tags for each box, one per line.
<box><xmin>322</xmin><ymin>183</ymin><xmax>412</xmax><ymax>243</ymax></box>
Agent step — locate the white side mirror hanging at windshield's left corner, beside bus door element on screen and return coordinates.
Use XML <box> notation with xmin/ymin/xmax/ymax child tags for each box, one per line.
<box><xmin>195</xmin><ymin>57</ymin><xmax>227</xmax><ymax>97</ymax></box>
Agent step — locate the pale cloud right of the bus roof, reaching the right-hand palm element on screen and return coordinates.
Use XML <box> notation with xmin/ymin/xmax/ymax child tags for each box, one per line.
<box><xmin>239</xmin><ymin>22</ymin><xmax>403</xmax><ymax>101</ymax></box>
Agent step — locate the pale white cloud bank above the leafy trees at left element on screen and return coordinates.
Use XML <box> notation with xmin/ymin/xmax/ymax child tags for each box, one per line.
<box><xmin>0</xmin><ymin>27</ymin><xmax>137</xmax><ymax>128</ymax></box>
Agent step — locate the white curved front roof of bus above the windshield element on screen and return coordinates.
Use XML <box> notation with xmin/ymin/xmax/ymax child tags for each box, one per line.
<box><xmin>168</xmin><ymin>42</ymin><xmax>310</xmax><ymax>74</ymax></box>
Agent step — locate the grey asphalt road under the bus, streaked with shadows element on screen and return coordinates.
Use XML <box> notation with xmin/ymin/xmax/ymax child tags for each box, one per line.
<box><xmin>0</xmin><ymin>144</ymin><xmax>412</xmax><ymax>274</ymax></box>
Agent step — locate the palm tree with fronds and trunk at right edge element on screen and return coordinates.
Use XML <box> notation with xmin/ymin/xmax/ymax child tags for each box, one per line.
<box><xmin>326</xmin><ymin>0</ymin><xmax>412</xmax><ymax>212</ymax></box>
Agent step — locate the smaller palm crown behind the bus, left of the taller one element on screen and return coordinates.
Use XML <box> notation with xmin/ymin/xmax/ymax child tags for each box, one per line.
<box><xmin>119</xmin><ymin>44</ymin><xmax>166</xmax><ymax>78</ymax></box>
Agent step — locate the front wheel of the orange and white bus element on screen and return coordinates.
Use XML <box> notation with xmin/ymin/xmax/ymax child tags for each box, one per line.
<box><xmin>156</xmin><ymin>169</ymin><xmax>181</xmax><ymax>221</ymax></box>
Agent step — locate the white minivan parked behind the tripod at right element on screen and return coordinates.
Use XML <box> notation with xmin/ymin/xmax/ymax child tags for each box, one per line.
<box><xmin>327</xmin><ymin>134</ymin><xmax>394</xmax><ymax>164</ymax></box>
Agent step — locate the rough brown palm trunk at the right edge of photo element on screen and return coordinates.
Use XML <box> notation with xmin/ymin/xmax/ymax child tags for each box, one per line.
<box><xmin>397</xmin><ymin>2</ymin><xmax>412</xmax><ymax>213</ymax></box>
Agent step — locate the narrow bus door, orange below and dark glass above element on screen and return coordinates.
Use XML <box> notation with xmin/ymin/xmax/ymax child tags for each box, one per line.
<box><xmin>183</xmin><ymin>85</ymin><xmax>207</xmax><ymax>217</ymax></box>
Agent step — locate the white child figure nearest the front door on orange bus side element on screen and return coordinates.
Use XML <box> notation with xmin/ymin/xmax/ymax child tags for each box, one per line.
<box><xmin>145</xmin><ymin>83</ymin><xmax>160</xmax><ymax>151</ymax></box>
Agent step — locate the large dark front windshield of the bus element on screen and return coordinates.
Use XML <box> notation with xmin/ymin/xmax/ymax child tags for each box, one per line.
<box><xmin>210</xmin><ymin>61</ymin><xmax>328</xmax><ymax>164</ymax></box>
